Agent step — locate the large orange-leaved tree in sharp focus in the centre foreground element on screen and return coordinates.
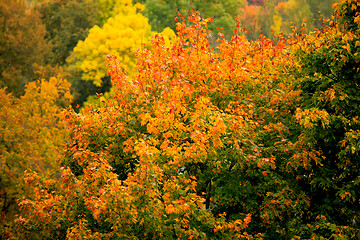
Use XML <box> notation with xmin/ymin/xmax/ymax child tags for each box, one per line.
<box><xmin>14</xmin><ymin>11</ymin><xmax>300</xmax><ymax>239</ymax></box>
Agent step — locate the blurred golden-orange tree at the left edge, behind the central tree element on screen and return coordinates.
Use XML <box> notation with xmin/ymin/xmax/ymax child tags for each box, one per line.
<box><xmin>0</xmin><ymin>77</ymin><xmax>72</xmax><ymax>236</ymax></box>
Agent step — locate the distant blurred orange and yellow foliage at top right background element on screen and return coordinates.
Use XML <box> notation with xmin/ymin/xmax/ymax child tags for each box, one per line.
<box><xmin>239</xmin><ymin>0</ymin><xmax>335</xmax><ymax>40</ymax></box>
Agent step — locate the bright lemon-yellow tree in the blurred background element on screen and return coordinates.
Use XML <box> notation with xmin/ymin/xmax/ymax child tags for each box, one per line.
<box><xmin>68</xmin><ymin>0</ymin><xmax>175</xmax><ymax>86</ymax></box>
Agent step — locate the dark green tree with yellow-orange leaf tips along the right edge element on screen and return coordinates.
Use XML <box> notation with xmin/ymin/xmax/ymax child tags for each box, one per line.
<box><xmin>290</xmin><ymin>1</ymin><xmax>360</xmax><ymax>238</ymax></box>
